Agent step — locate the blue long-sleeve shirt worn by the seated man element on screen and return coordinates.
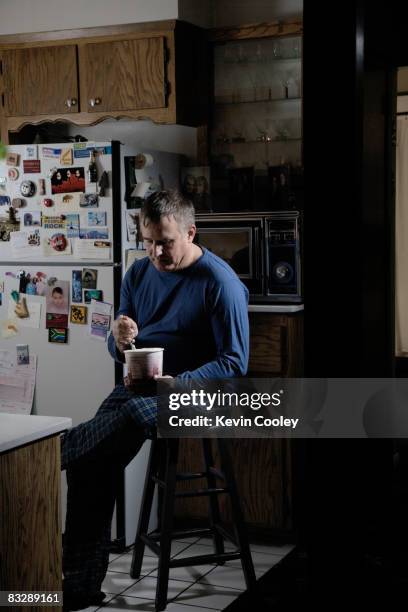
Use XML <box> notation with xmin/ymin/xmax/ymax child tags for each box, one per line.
<box><xmin>108</xmin><ymin>249</ymin><xmax>249</xmax><ymax>379</ymax></box>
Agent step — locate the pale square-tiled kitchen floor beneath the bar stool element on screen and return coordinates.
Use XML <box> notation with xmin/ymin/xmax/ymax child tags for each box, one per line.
<box><xmin>83</xmin><ymin>538</ymin><xmax>293</xmax><ymax>612</ymax></box>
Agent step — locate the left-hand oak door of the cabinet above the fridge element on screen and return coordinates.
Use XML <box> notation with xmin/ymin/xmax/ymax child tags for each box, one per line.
<box><xmin>1</xmin><ymin>45</ymin><xmax>78</xmax><ymax>117</ymax></box>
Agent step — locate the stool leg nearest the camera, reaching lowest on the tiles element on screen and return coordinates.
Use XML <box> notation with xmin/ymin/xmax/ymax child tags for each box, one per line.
<box><xmin>155</xmin><ymin>439</ymin><xmax>179</xmax><ymax>611</ymax></box>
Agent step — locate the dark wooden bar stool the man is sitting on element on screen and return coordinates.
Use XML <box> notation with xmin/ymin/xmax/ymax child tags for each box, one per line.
<box><xmin>130</xmin><ymin>438</ymin><xmax>256</xmax><ymax>611</ymax></box>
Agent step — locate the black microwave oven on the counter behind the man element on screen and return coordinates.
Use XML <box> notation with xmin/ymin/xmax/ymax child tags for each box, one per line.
<box><xmin>194</xmin><ymin>211</ymin><xmax>302</xmax><ymax>303</ymax></box>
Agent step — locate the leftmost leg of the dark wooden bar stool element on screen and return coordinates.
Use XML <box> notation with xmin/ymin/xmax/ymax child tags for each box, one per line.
<box><xmin>130</xmin><ymin>440</ymin><xmax>158</xmax><ymax>578</ymax></box>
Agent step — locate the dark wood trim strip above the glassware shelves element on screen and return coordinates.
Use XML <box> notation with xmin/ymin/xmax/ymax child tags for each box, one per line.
<box><xmin>209</xmin><ymin>21</ymin><xmax>303</xmax><ymax>42</ymax></box>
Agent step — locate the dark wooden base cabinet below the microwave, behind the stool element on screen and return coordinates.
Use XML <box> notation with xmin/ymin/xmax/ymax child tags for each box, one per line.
<box><xmin>176</xmin><ymin>312</ymin><xmax>303</xmax><ymax>541</ymax></box>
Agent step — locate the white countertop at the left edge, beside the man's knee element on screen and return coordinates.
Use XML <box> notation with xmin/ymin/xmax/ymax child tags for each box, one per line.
<box><xmin>0</xmin><ymin>413</ymin><xmax>72</xmax><ymax>453</ymax></box>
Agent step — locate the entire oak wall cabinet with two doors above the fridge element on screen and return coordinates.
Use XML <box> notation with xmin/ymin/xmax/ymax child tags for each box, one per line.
<box><xmin>0</xmin><ymin>21</ymin><xmax>209</xmax><ymax>140</ymax></box>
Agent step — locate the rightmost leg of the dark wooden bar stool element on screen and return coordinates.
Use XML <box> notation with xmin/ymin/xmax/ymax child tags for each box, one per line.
<box><xmin>218</xmin><ymin>438</ymin><xmax>256</xmax><ymax>590</ymax></box>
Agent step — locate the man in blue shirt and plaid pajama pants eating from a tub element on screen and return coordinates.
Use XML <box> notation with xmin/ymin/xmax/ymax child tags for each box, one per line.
<box><xmin>62</xmin><ymin>191</ymin><xmax>249</xmax><ymax>610</ymax></box>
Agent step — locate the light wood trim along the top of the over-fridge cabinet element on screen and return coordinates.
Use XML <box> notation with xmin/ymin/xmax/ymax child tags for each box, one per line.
<box><xmin>0</xmin><ymin>19</ymin><xmax>177</xmax><ymax>49</ymax></box>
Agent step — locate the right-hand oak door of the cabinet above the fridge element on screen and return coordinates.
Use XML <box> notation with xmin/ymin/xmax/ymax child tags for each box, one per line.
<box><xmin>81</xmin><ymin>36</ymin><xmax>167</xmax><ymax>113</ymax></box>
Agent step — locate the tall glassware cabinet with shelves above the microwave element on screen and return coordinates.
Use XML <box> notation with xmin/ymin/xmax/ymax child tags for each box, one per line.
<box><xmin>210</xmin><ymin>24</ymin><xmax>303</xmax><ymax>212</ymax></box>
